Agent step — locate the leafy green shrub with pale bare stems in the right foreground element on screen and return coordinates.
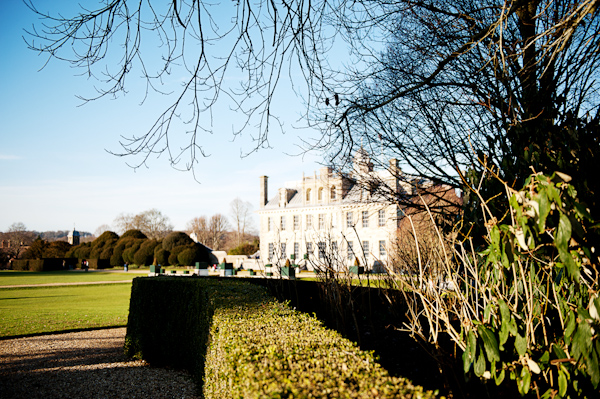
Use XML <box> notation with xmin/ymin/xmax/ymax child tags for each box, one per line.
<box><xmin>403</xmin><ymin>173</ymin><xmax>600</xmax><ymax>398</ymax></box>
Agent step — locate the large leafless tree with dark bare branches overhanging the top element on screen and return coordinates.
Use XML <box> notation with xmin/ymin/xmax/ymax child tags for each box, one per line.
<box><xmin>28</xmin><ymin>0</ymin><xmax>600</xmax><ymax>222</ymax></box>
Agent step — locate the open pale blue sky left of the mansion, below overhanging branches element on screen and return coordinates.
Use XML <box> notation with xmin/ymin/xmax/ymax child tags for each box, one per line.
<box><xmin>0</xmin><ymin>0</ymin><xmax>328</xmax><ymax>233</ymax></box>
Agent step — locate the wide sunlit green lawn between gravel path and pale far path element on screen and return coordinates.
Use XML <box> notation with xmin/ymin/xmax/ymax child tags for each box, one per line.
<box><xmin>0</xmin><ymin>283</ymin><xmax>131</xmax><ymax>337</ymax></box>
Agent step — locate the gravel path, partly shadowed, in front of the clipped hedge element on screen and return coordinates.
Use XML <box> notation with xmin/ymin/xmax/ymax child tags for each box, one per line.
<box><xmin>0</xmin><ymin>328</ymin><xmax>198</xmax><ymax>399</ymax></box>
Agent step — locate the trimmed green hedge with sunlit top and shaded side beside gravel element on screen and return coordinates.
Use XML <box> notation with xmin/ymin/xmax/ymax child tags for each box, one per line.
<box><xmin>126</xmin><ymin>277</ymin><xmax>434</xmax><ymax>399</ymax></box>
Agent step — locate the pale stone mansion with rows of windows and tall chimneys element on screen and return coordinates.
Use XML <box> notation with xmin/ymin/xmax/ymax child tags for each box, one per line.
<box><xmin>257</xmin><ymin>149</ymin><xmax>411</xmax><ymax>270</ymax></box>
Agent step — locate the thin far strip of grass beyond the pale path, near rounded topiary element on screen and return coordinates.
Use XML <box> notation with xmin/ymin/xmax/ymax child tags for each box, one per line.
<box><xmin>0</xmin><ymin>270</ymin><xmax>146</xmax><ymax>286</ymax></box>
